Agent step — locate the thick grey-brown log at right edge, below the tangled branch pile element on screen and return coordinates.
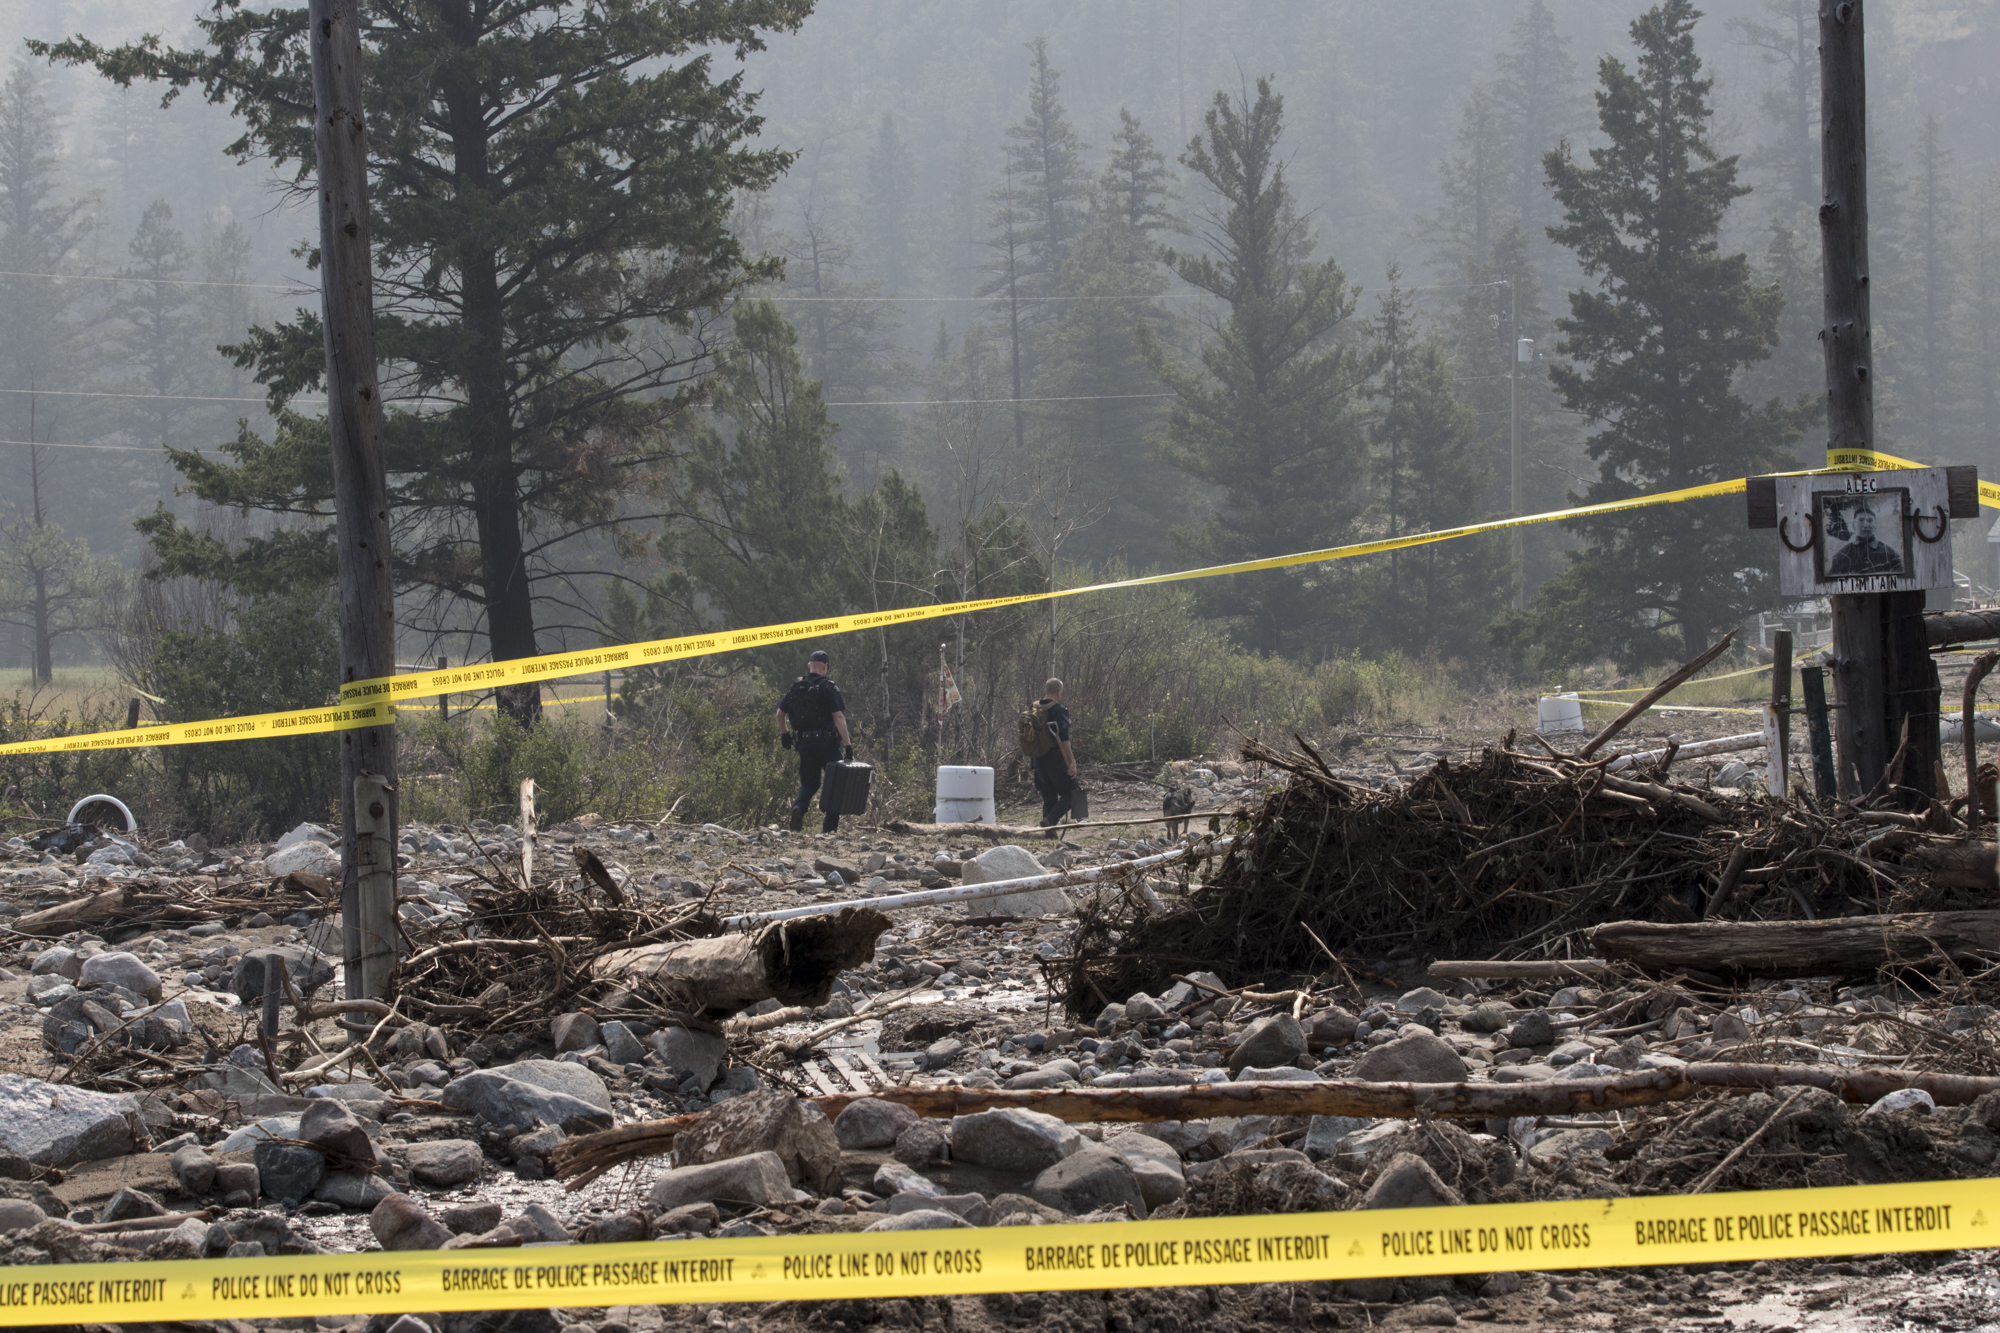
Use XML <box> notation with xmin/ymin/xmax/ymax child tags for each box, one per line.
<box><xmin>1588</xmin><ymin>911</ymin><xmax>2000</xmax><ymax>977</ymax></box>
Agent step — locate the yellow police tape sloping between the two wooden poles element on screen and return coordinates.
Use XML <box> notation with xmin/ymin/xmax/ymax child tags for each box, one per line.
<box><xmin>0</xmin><ymin>450</ymin><xmax>1968</xmax><ymax>755</ymax></box>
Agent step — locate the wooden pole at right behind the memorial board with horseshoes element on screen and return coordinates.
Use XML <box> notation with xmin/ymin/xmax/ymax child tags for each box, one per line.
<box><xmin>1820</xmin><ymin>0</ymin><xmax>1938</xmax><ymax>799</ymax></box>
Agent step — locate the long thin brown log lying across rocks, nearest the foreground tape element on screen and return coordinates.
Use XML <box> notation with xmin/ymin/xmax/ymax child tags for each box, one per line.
<box><xmin>548</xmin><ymin>1065</ymin><xmax>2000</xmax><ymax>1189</ymax></box>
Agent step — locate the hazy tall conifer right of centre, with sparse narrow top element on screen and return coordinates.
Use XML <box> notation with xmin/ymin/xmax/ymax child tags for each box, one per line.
<box><xmin>1140</xmin><ymin>78</ymin><xmax>1378</xmax><ymax>650</ymax></box>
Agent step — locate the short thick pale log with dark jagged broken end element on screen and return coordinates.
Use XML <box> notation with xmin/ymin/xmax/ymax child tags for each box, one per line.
<box><xmin>590</xmin><ymin>907</ymin><xmax>890</xmax><ymax>1019</ymax></box>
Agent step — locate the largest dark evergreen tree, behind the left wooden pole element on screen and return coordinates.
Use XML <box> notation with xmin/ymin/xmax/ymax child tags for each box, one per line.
<box><xmin>41</xmin><ymin>0</ymin><xmax>810</xmax><ymax>721</ymax></box>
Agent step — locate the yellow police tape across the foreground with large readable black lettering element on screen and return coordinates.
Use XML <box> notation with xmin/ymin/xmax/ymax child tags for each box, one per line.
<box><xmin>0</xmin><ymin>1179</ymin><xmax>2000</xmax><ymax>1325</ymax></box>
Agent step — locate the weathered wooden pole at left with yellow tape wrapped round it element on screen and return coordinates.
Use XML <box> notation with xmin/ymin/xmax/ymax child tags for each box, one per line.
<box><xmin>306</xmin><ymin>0</ymin><xmax>396</xmax><ymax>999</ymax></box>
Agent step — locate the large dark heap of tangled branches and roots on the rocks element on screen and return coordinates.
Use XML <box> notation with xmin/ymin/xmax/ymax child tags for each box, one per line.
<box><xmin>1050</xmin><ymin>735</ymin><xmax>1976</xmax><ymax>1013</ymax></box>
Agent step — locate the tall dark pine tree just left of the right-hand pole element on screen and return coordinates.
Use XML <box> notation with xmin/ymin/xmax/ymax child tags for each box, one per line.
<box><xmin>1516</xmin><ymin>0</ymin><xmax>1804</xmax><ymax>660</ymax></box>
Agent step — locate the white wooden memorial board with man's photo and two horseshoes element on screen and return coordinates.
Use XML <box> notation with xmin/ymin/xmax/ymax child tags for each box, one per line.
<box><xmin>1750</xmin><ymin>468</ymin><xmax>1952</xmax><ymax>596</ymax></box>
